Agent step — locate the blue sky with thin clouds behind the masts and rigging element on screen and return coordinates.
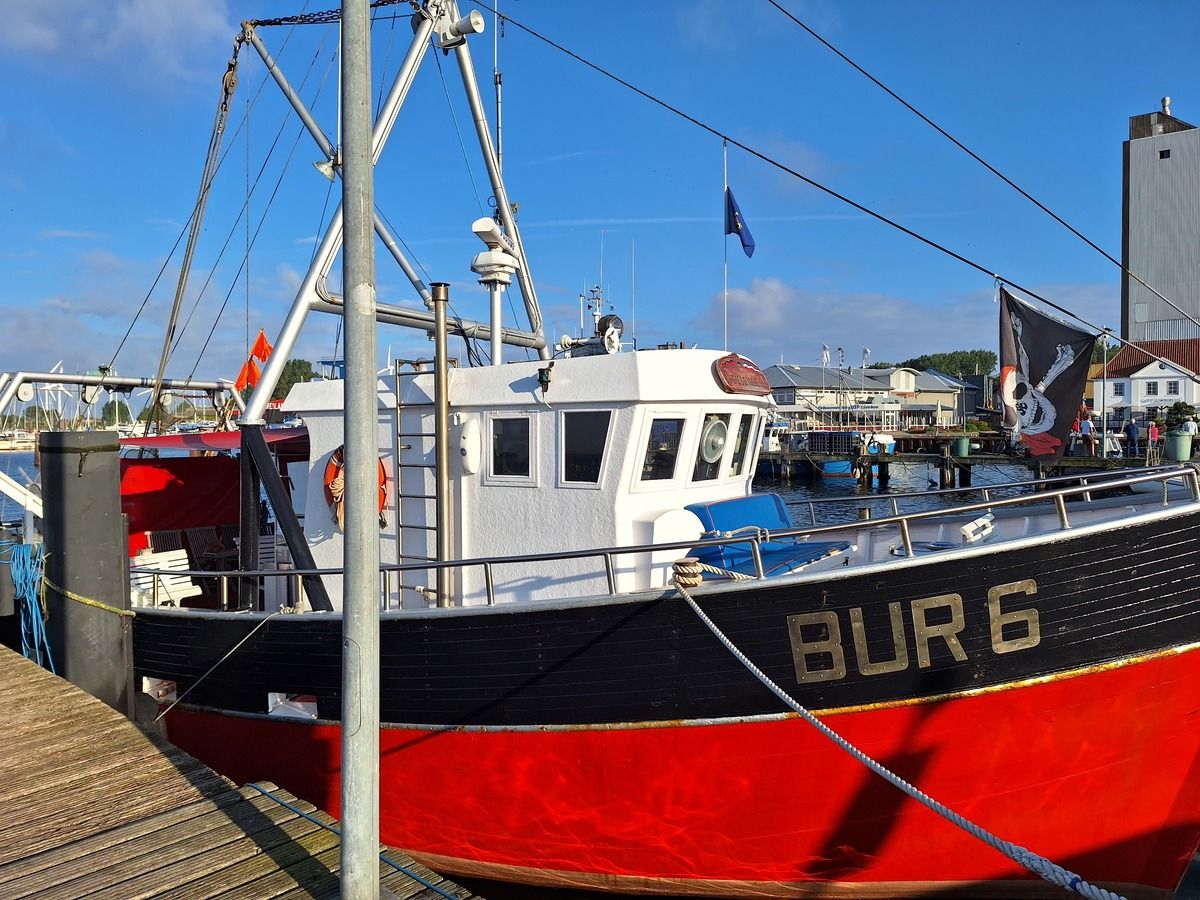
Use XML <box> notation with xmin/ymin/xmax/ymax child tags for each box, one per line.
<box><xmin>0</xmin><ymin>0</ymin><xmax>1200</xmax><ymax>393</ymax></box>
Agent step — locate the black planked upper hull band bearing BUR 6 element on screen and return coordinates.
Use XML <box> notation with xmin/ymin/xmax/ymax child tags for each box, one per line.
<box><xmin>133</xmin><ymin>514</ymin><xmax>1200</xmax><ymax>726</ymax></box>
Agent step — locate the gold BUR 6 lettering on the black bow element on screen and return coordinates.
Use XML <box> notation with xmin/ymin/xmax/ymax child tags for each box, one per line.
<box><xmin>787</xmin><ymin>578</ymin><xmax>1042</xmax><ymax>684</ymax></box>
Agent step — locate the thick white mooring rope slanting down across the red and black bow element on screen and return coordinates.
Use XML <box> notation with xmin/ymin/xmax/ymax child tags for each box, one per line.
<box><xmin>672</xmin><ymin>557</ymin><xmax>1126</xmax><ymax>900</ymax></box>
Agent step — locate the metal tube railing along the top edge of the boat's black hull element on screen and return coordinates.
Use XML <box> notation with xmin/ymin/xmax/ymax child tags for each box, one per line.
<box><xmin>131</xmin><ymin>466</ymin><xmax>1200</xmax><ymax>610</ymax></box>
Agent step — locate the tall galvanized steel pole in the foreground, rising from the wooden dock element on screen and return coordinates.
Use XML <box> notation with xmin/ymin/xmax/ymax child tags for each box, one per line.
<box><xmin>341</xmin><ymin>0</ymin><xmax>379</xmax><ymax>900</ymax></box>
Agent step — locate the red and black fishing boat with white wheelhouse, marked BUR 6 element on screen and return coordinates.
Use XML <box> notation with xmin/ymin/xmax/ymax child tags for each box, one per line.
<box><xmin>7</xmin><ymin>2</ymin><xmax>1200</xmax><ymax>898</ymax></box>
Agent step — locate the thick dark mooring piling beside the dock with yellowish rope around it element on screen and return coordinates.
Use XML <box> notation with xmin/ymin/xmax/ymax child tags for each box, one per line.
<box><xmin>38</xmin><ymin>431</ymin><xmax>132</xmax><ymax>713</ymax></box>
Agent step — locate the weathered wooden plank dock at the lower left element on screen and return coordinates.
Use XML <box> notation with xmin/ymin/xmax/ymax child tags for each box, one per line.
<box><xmin>0</xmin><ymin>647</ymin><xmax>474</xmax><ymax>900</ymax></box>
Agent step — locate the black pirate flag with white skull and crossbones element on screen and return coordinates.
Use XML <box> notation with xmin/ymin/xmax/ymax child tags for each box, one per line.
<box><xmin>1000</xmin><ymin>287</ymin><xmax>1097</xmax><ymax>463</ymax></box>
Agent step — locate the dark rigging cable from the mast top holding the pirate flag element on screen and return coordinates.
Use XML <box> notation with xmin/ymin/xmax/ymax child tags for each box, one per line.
<box><xmin>470</xmin><ymin>0</ymin><xmax>1200</xmax><ymax>384</ymax></box>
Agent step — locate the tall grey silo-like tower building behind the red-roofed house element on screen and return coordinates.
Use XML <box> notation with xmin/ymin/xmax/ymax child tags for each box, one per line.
<box><xmin>1121</xmin><ymin>97</ymin><xmax>1200</xmax><ymax>341</ymax></box>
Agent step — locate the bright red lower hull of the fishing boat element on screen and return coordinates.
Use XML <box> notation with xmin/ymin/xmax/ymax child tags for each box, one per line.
<box><xmin>167</xmin><ymin>649</ymin><xmax>1200</xmax><ymax>896</ymax></box>
